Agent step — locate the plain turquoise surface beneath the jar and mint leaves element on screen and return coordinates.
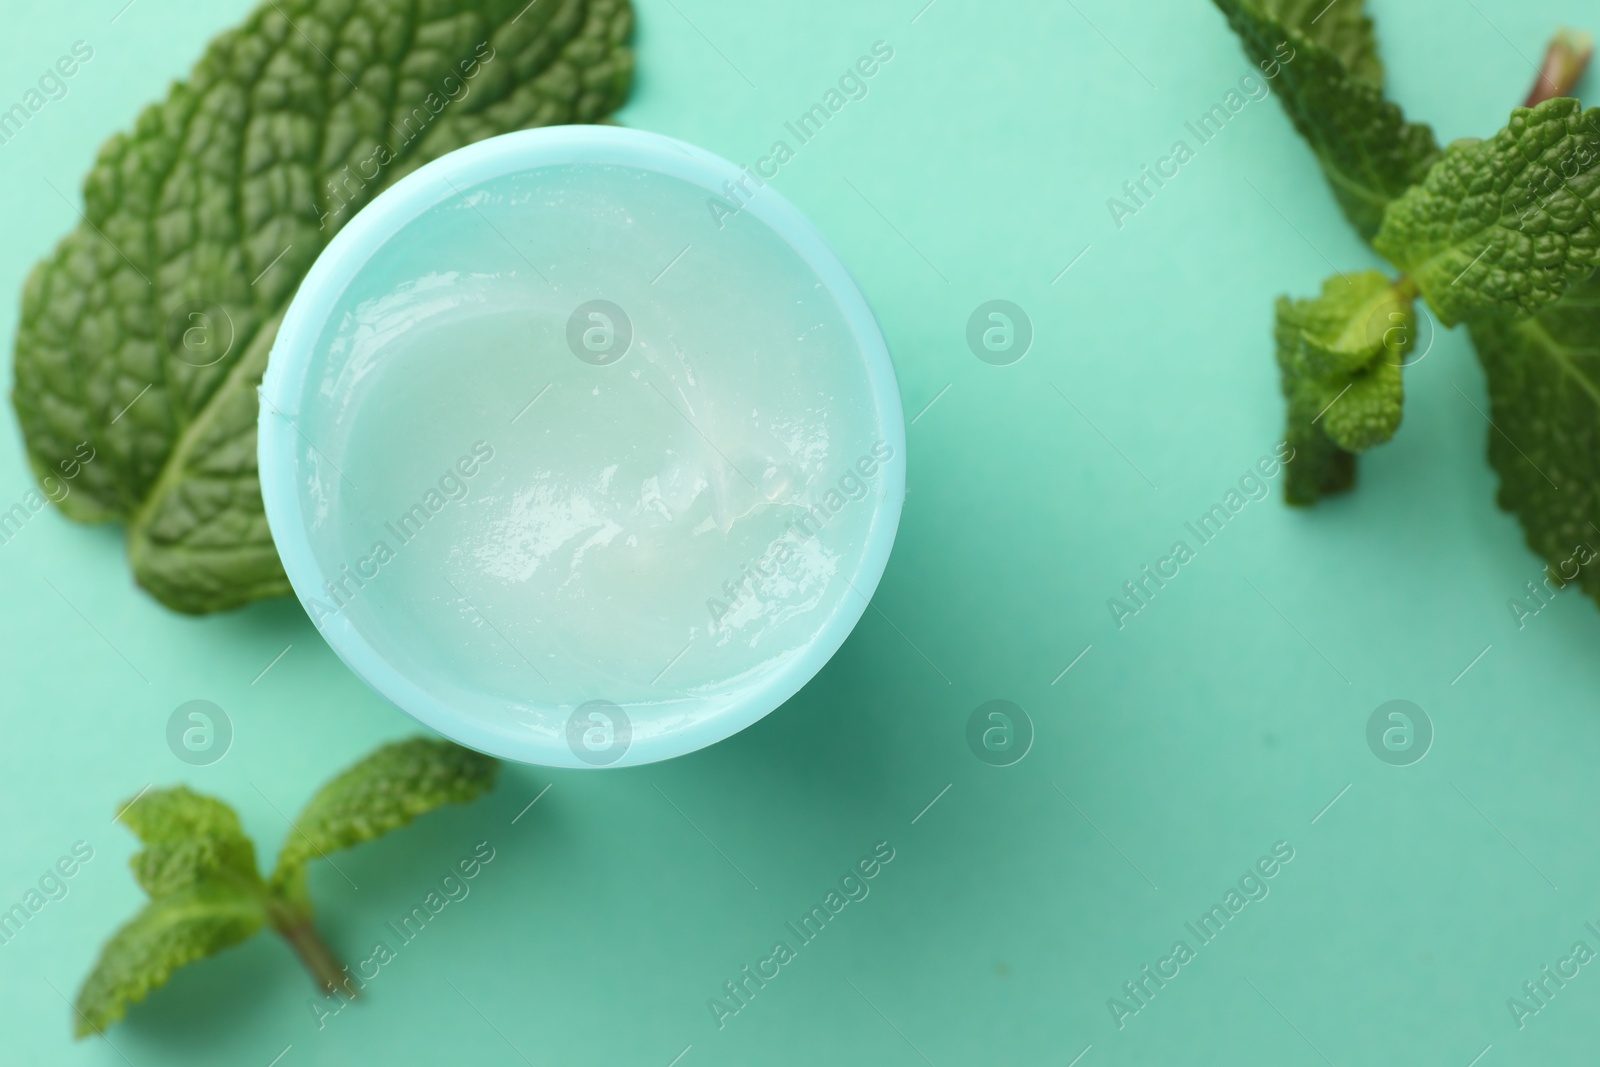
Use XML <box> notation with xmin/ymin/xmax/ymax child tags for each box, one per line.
<box><xmin>0</xmin><ymin>0</ymin><xmax>1600</xmax><ymax>1067</ymax></box>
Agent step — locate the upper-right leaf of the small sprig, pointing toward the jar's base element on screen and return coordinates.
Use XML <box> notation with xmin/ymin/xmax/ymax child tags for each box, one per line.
<box><xmin>272</xmin><ymin>737</ymin><xmax>499</xmax><ymax>901</ymax></box>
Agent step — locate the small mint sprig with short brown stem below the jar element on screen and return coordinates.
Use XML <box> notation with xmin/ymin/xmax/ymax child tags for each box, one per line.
<box><xmin>74</xmin><ymin>737</ymin><xmax>499</xmax><ymax>1038</ymax></box>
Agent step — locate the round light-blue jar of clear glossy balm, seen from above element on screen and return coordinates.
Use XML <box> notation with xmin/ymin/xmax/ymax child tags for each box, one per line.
<box><xmin>258</xmin><ymin>126</ymin><xmax>906</xmax><ymax>766</ymax></box>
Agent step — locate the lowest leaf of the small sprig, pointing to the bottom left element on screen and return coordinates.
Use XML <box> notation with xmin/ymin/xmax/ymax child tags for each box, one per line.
<box><xmin>72</xmin><ymin>883</ymin><xmax>267</xmax><ymax>1037</ymax></box>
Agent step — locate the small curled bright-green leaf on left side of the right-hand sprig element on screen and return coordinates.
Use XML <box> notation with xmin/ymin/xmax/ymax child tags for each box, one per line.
<box><xmin>1274</xmin><ymin>270</ymin><xmax>1416</xmax><ymax>504</ymax></box>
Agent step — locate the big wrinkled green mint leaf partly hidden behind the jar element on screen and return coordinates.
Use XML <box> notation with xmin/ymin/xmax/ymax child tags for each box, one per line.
<box><xmin>13</xmin><ymin>0</ymin><xmax>632</xmax><ymax>613</ymax></box>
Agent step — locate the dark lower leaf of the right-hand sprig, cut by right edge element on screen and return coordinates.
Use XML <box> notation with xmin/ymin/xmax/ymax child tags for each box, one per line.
<box><xmin>1469</xmin><ymin>278</ymin><xmax>1600</xmax><ymax>600</ymax></box>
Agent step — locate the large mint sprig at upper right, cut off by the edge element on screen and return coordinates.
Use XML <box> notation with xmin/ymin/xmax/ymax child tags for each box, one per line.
<box><xmin>1214</xmin><ymin>0</ymin><xmax>1600</xmax><ymax>600</ymax></box>
